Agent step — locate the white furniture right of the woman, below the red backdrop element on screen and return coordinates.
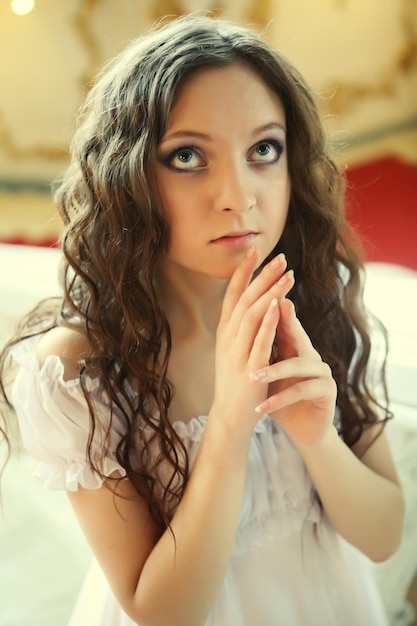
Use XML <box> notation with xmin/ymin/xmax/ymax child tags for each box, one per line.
<box><xmin>365</xmin><ymin>263</ymin><xmax>417</xmax><ymax>626</ymax></box>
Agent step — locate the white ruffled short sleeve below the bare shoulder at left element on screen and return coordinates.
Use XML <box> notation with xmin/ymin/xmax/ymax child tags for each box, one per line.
<box><xmin>12</xmin><ymin>338</ymin><xmax>126</xmax><ymax>491</ymax></box>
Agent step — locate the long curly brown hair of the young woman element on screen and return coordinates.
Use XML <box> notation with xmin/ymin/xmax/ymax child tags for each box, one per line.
<box><xmin>1</xmin><ymin>16</ymin><xmax>388</xmax><ymax>525</ymax></box>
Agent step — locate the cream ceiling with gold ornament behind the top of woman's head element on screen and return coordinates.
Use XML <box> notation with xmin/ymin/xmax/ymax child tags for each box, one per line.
<box><xmin>0</xmin><ymin>0</ymin><xmax>417</xmax><ymax>181</ymax></box>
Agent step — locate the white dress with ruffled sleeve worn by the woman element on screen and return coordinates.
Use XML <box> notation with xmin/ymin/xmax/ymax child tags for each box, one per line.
<box><xmin>12</xmin><ymin>340</ymin><xmax>388</xmax><ymax>626</ymax></box>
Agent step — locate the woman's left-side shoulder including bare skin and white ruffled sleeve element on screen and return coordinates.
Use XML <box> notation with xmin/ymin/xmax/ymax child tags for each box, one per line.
<box><xmin>11</xmin><ymin>326</ymin><xmax>126</xmax><ymax>491</ymax></box>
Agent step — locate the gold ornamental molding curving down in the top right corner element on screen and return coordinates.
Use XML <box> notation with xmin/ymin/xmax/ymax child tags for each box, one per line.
<box><xmin>328</xmin><ymin>0</ymin><xmax>417</xmax><ymax>116</ymax></box>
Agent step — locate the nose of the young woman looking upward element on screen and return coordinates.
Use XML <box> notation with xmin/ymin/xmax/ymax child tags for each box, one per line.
<box><xmin>209</xmin><ymin>164</ymin><xmax>256</xmax><ymax>213</ymax></box>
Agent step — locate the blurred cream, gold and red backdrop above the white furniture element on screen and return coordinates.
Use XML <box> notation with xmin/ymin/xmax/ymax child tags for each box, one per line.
<box><xmin>0</xmin><ymin>0</ymin><xmax>417</xmax><ymax>268</ymax></box>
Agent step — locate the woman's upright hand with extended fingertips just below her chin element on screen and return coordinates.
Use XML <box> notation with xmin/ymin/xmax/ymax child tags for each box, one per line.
<box><xmin>210</xmin><ymin>248</ymin><xmax>294</xmax><ymax>432</ymax></box>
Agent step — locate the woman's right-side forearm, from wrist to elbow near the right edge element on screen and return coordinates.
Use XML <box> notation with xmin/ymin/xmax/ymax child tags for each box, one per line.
<box><xmin>299</xmin><ymin>427</ymin><xmax>404</xmax><ymax>561</ymax></box>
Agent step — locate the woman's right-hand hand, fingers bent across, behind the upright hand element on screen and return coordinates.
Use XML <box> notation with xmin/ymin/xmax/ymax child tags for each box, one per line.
<box><xmin>250</xmin><ymin>299</ymin><xmax>337</xmax><ymax>447</ymax></box>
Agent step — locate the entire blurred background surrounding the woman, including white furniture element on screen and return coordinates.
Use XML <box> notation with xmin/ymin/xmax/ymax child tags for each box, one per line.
<box><xmin>0</xmin><ymin>0</ymin><xmax>417</xmax><ymax>626</ymax></box>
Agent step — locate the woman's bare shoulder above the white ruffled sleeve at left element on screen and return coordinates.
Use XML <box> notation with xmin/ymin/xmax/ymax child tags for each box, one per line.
<box><xmin>35</xmin><ymin>326</ymin><xmax>89</xmax><ymax>380</ymax></box>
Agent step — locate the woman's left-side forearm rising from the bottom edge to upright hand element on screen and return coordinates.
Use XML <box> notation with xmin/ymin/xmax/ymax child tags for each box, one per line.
<box><xmin>135</xmin><ymin>420</ymin><xmax>250</xmax><ymax>626</ymax></box>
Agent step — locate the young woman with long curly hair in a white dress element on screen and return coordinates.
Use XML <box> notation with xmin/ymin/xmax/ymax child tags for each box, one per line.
<box><xmin>3</xmin><ymin>16</ymin><xmax>403</xmax><ymax>626</ymax></box>
